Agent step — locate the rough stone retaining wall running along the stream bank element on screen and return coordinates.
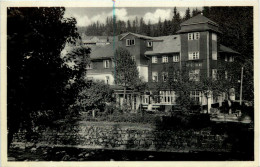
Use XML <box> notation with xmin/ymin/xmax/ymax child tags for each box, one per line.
<box><xmin>13</xmin><ymin>123</ymin><xmax>231</xmax><ymax>152</ymax></box>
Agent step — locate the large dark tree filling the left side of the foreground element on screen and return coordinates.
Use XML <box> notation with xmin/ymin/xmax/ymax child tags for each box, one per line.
<box><xmin>7</xmin><ymin>7</ymin><xmax>79</xmax><ymax>146</ymax></box>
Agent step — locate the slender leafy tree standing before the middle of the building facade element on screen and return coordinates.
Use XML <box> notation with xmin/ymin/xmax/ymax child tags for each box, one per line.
<box><xmin>115</xmin><ymin>47</ymin><xmax>139</xmax><ymax>103</ymax></box>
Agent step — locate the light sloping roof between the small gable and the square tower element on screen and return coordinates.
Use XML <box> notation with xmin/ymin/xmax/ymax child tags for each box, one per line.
<box><xmin>145</xmin><ymin>35</ymin><xmax>181</xmax><ymax>55</ymax></box>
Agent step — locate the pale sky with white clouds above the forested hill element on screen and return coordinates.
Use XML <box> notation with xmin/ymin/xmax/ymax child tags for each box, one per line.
<box><xmin>65</xmin><ymin>7</ymin><xmax>202</xmax><ymax>26</ymax></box>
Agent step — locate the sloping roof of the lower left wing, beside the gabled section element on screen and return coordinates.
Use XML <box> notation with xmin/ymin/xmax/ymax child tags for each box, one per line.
<box><xmin>90</xmin><ymin>44</ymin><xmax>114</xmax><ymax>60</ymax></box>
